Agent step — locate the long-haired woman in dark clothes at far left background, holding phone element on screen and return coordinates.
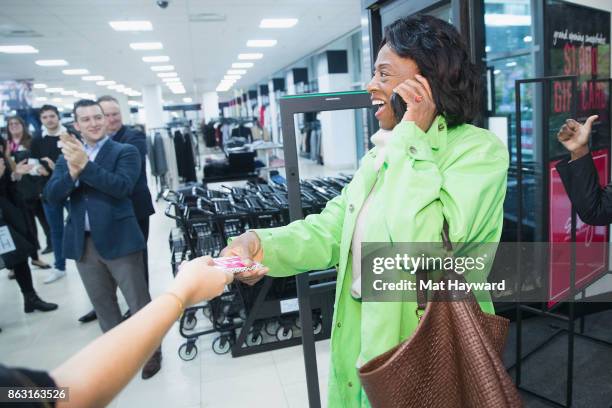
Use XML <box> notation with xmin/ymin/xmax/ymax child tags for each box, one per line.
<box><xmin>7</xmin><ymin>116</ymin><xmax>51</xmax><ymax>269</ymax></box>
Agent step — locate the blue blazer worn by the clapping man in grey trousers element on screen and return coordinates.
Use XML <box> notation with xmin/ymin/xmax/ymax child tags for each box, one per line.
<box><xmin>44</xmin><ymin>140</ymin><xmax>145</xmax><ymax>260</ymax></box>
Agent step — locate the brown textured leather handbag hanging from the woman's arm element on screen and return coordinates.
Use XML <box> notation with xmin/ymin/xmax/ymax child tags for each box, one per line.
<box><xmin>359</xmin><ymin>221</ymin><xmax>522</xmax><ymax>408</ymax></box>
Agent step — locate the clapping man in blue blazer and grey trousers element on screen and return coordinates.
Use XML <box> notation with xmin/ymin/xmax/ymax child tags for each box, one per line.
<box><xmin>44</xmin><ymin>100</ymin><xmax>161</xmax><ymax>378</ymax></box>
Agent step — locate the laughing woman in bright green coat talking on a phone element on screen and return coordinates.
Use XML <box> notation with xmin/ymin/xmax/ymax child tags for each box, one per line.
<box><xmin>224</xmin><ymin>16</ymin><xmax>508</xmax><ymax>407</ymax></box>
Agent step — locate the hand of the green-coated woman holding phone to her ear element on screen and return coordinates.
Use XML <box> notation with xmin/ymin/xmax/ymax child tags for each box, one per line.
<box><xmin>393</xmin><ymin>74</ymin><xmax>436</xmax><ymax>132</ymax></box>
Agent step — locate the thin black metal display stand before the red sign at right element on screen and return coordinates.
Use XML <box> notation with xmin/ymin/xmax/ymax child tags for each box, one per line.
<box><xmin>507</xmin><ymin>75</ymin><xmax>612</xmax><ymax>408</ymax></box>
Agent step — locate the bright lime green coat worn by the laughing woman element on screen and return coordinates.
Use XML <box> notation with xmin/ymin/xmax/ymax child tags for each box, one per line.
<box><xmin>256</xmin><ymin>116</ymin><xmax>508</xmax><ymax>407</ymax></box>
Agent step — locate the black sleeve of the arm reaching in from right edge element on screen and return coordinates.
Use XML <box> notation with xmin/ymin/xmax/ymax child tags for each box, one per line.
<box><xmin>557</xmin><ymin>154</ymin><xmax>612</xmax><ymax>225</ymax></box>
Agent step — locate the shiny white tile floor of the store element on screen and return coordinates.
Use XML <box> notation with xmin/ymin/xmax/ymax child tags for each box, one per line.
<box><xmin>0</xmin><ymin>157</ymin><xmax>340</xmax><ymax>408</ymax></box>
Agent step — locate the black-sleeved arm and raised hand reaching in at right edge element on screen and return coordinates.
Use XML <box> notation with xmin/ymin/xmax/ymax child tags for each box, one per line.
<box><xmin>556</xmin><ymin>115</ymin><xmax>612</xmax><ymax>225</ymax></box>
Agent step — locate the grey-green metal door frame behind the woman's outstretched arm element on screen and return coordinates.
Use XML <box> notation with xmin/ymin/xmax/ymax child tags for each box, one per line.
<box><xmin>280</xmin><ymin>91</ymin><xmax>372</xmax><ymax>408</ymax></box>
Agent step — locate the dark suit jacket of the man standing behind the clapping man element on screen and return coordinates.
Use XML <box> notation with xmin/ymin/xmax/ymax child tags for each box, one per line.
<box><xmin>113</xmin><ymin>125</ymin><xmax>155</xmax><ymax>220</ymax></box>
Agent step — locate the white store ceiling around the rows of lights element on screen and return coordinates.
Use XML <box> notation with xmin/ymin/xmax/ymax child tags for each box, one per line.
<box><xmin>0</xmin><ymin>0</ymin><xmax>361</xmax><ymax>107</ymax></box>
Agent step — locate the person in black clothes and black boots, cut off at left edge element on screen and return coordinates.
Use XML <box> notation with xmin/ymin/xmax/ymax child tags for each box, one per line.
<box><xmin>0</xmin><ymin>139</ymin><xmax>57</xmax><ymax>322</ymax></box>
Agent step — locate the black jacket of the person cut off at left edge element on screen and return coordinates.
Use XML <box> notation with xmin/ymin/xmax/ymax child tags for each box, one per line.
<box><xmin>0</xmin><ymin>166</ymin><xmax>36</xmax><ymax>269</ymax></box>
